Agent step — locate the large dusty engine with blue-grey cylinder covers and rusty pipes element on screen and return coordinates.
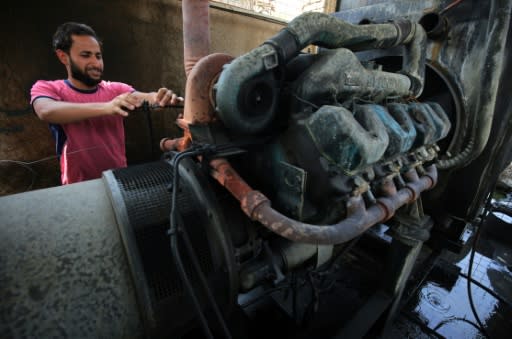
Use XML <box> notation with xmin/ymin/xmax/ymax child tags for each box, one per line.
<box><xmin>129</xmin><ymin>3</ymin><xmax>454</xmax><ymax>337</ymax></box>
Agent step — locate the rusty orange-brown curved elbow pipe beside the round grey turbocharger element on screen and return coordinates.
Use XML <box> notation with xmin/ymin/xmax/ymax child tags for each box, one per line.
<box><xmin>160</xmin><ymin>53</ymin><xmax>233</xmax><ymax>151</ymax></box>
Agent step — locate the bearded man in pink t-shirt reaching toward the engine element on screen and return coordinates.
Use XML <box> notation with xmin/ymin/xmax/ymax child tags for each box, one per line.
<box><xmin>31</xmin><ymin>22</ymin><xmax>183</xmax><ymax>185</ymax></box>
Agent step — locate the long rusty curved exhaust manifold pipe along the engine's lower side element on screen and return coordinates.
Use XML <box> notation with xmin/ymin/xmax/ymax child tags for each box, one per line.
<box><xmin>210</xmin><ymin>159</ymin><xmax>437</xmax><ymax>244</ymax></box>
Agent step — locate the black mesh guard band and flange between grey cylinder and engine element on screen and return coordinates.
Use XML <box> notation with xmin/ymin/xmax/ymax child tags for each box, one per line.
<box><xmin>103</xmin><ymin>160</ymin><xmax>234</xmax><ymax>337</ymax></box>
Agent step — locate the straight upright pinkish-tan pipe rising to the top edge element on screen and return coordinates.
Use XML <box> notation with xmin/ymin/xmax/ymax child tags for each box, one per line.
<box><xmin>182</xmin><ymin>0</ymin><xmax>210</xmax><ymax>77</ymax></box>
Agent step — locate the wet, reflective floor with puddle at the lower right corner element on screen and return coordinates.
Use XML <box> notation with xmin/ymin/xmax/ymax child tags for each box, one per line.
<box><xmin>390</xmin><ymin>206</ymin><xmax>512</xmax><ymax>338</ymax></box>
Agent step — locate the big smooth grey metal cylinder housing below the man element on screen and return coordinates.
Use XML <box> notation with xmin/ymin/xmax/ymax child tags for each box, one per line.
<box><xmin>0</xmin><ymin>179</ymin><xmax>143</xmax><ymax>338</ymax></box>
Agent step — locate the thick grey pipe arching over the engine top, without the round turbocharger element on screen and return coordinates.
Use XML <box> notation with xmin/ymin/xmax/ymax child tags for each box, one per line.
<box><xmin>218</xmin><ymin>12</ymin><xmax>426</xmax><ymax>96</ymax></box>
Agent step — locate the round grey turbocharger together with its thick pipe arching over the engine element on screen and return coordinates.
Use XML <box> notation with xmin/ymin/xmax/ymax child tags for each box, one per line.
<box><xmin>216</xmin><ymin>12</ymin><xmax>426</xmax><ymax>134</ymax></box>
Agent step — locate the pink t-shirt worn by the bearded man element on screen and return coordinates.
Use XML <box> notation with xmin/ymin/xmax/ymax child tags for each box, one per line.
<box><xmin>30</xmin><ymin>80</ymin><xmax>134</xmax><ymax>185</ymax></box>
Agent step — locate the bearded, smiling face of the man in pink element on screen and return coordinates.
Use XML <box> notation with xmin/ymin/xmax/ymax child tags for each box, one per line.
<box><xmin>69</xmin><ymin>35</ymin><xmax>103</xmax><ymax>87</ymax></box>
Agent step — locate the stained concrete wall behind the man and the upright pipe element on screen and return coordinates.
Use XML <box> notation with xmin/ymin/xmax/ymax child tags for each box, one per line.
<box><xmin>0</xmin><ymin>0</ymin><xmax>283</xmax><ymax>195</ymax></box>
